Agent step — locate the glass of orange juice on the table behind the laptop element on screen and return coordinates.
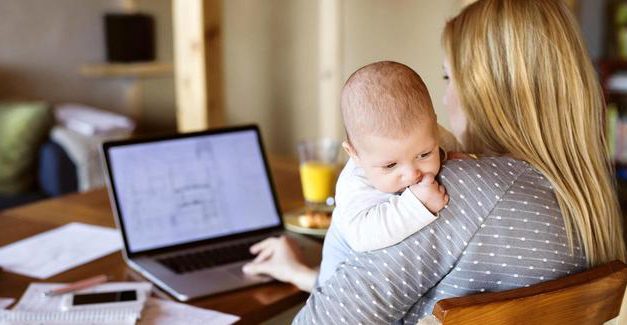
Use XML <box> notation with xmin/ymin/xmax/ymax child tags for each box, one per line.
<box><xmin>298</xmin><ymin>139</ymin><xmax>340</xmax><ymax>216</ymax></box>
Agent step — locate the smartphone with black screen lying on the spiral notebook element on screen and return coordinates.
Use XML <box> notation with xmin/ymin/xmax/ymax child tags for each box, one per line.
<box><xmin>62</xmin><ymin>290</ymin><xmax>140</xmax><ymax>310</ymax></box>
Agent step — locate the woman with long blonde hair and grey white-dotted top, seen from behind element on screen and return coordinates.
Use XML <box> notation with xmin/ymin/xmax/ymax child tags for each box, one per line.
<box><xmin>243</xmin><ymin>0</ymin><xmax>625</xmax><ymax>324</ymax></box>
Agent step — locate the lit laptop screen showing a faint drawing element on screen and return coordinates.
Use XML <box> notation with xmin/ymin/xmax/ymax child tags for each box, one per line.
<box><xmin>107</xmin><ymin>129</ymin><xmax>281</xmax><ymax>253</ymax></box>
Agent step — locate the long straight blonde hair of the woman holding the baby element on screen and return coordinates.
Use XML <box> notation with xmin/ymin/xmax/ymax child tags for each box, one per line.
<box><xmin>443</xmin><ymin>0</ymin><xmax>625</xmax><ymax>266</ymax></box>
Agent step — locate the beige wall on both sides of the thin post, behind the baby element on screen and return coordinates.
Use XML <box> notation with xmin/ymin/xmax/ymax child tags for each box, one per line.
<box><xmin>223</xmin><ymin>0</ymin><xmax>459</xmax><ymax>154</ymax></box>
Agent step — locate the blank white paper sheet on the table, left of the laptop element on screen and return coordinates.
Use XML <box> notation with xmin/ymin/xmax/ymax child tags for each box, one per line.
<box><xmin>0</xmin><ymin>222</ymin><xmax>122</xmax><ymax>279</ymax></box>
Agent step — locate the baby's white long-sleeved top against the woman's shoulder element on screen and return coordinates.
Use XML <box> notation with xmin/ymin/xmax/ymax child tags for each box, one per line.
<box><xmin>332</xmin><ymin>161</ymin><xmax>436</xmax><ymax>252</ymax></box>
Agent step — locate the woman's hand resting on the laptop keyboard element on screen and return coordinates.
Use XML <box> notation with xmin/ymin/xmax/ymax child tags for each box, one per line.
<box><xmin>242</xmin><ymin>236</ymin><xmax>318</xmax><ymax>292</ymax></box>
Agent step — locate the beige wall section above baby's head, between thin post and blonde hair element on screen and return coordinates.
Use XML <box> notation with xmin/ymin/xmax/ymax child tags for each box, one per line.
<box><xmin>344</xmin><ymin>0</ymin><xmax>460</xmax><ymax>130</ymax></box>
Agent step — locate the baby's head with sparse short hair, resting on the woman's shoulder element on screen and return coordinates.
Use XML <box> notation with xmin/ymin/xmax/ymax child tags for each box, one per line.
<box><xmin>341</xmin><ymin>61</ymin><xmax>440</xmax><ymax>193</ymax></box>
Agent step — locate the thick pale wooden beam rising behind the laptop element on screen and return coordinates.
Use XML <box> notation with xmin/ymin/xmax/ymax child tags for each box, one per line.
<box><xmin>172</xmin><ymin>0</ymin><xmax>224</xmax><ymax>132</ymax></box>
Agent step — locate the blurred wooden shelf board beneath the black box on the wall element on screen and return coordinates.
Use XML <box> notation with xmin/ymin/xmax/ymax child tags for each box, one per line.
<box><xmin>79</xmin><ymin>62</ymin><xmax>174</xmax><ymax>78</ymax></box>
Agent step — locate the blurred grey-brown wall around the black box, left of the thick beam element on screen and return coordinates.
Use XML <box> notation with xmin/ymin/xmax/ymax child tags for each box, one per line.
<box><xmin>0</xmin><ymin>0</ymin><xmax>175</xmax><ymax>129</ymax></box>
